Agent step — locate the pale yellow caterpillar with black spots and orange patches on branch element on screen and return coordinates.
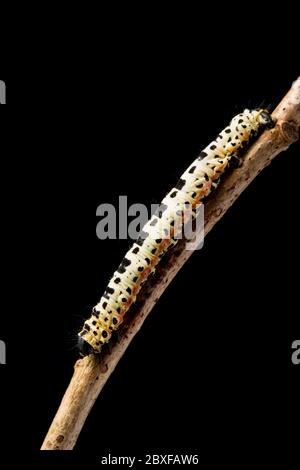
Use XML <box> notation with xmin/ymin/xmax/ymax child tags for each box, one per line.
<box><xmin>78</xmin><ymin>109</ymin><xmax>274</xmax><ymax>355</ymax></box>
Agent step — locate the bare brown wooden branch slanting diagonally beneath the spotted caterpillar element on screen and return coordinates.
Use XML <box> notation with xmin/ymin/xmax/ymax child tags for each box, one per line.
<box><xmin>42</xmin><ymin>77</ymin><xmax>300</xmax><ymax>450</ymax></box>
